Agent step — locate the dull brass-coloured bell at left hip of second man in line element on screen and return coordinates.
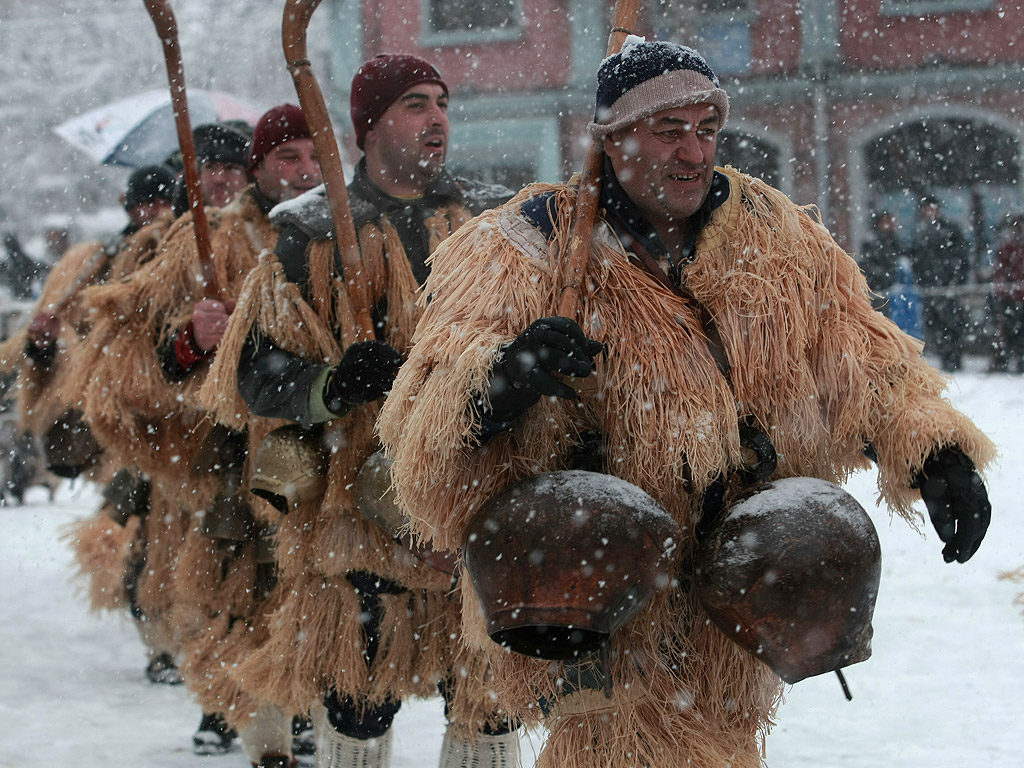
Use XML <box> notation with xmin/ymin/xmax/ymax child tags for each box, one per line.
<box><xmin>249</xmin><ymin>424</ymin><xmax>329</xmax><ymax>514</ymax></box>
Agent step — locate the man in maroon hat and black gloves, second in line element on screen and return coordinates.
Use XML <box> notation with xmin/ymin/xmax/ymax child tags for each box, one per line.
<box><xmin>204</xmin><ymin>54</ymin><xmax>518</xmax><ymax>768</ymax></box>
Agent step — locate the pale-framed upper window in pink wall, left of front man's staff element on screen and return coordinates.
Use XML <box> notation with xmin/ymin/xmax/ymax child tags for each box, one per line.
<box><xmin>421</xmin><ymin>0</ymin><xmax>522</xmax><ymax>45</ymax></box>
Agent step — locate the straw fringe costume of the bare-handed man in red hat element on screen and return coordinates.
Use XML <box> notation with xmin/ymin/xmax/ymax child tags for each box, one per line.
<box><xmin>74</xmin><ymin>187</ymin><xmax>276</xmax><ymax>726</ymax></box>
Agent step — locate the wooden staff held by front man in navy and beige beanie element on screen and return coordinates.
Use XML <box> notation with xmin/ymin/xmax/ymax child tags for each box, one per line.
<box><xmin>558</xmin><ymin>0</ymin><xmax>641</xmax><ymax>317</ymax></box>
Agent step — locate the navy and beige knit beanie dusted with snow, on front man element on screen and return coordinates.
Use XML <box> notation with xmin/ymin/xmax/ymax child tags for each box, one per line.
<box><xmin>587</xmin><ymin>35</ymin><xmax>729</xmax><ymax>138</ymax></box>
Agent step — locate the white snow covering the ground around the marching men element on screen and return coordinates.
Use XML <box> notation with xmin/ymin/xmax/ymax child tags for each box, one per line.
<box><xmin>0</xmin><ymin>373</ymin><xmax>1024</xmax><ymax>768</ymax></box>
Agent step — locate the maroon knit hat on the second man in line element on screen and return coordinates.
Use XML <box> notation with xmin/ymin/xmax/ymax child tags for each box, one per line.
<box><xmin>351</xmin><ymin>53</ymin><xmax>447</xmax><ymax>150</ymax></box>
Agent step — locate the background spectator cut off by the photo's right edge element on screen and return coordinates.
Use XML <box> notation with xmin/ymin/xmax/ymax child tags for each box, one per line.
<box><xmin>992</xmin><ymin>213</ymin><xmax>1024</xmax><ymax>374</ymax></box>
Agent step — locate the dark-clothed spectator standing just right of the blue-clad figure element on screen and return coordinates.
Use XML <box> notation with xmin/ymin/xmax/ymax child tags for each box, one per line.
<box><xmin>911</xmin><ymin>196</ymin><xmax>971</xmax><ymax>372</ymax></box>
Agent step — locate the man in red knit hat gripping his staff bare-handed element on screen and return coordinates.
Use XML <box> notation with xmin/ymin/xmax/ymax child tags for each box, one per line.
<box><xmin>76</xmin><ymin>104</ymin><xmax>321</xmax><ymax>766</ymax></box>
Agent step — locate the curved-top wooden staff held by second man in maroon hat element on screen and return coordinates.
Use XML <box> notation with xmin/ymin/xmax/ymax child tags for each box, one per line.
<box><xmin>282</xmin><ymin>0</ymin><xmax>374</xmax><ymax>340</ymax></box>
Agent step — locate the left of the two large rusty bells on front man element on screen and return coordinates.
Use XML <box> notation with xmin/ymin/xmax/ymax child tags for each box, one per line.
<box><xmin>463</xmin><ymin>470</ymin><xmax>681</xmax><ymax>659</ymax></box>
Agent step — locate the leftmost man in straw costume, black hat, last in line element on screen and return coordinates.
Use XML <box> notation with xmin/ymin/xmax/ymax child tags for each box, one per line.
<box><xmin>4</xmin><ymin>166</ymin><xmax>181</xmax><ymax>683</ymax></box>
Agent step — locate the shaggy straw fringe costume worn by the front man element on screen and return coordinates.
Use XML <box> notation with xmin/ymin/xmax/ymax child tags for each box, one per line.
<box><xmin>379</xmin><ymin>169</ymin><xmax>993</xmax><ymax>768</ymax></box>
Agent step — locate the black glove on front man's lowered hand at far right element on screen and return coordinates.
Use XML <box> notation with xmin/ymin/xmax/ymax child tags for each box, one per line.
<box><xmin>910</xmin><ymin>447</ymin><xmax>992</xmax><ymax>562</ymax></box>
